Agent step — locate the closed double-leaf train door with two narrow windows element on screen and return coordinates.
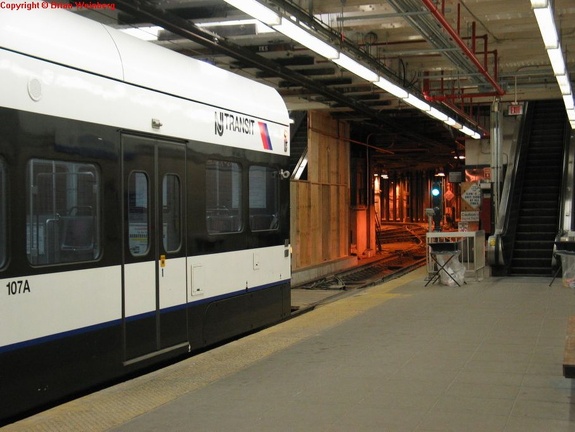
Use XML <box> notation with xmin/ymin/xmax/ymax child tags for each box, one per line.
<box><xmin>122</xmin><ymin>135</ymin><xmax>188</xmax><ymax>363</ymax></box>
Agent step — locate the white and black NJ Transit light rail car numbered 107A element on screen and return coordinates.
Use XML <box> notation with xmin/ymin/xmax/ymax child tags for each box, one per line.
<box><xmin>0</xmin><ymin>8</ymin><xmax>291</xmax><ymax>424</ymax></box>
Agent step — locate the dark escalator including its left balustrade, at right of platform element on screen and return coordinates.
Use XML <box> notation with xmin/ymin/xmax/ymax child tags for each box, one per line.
<box><xmin>492</xmin><ymin>100</ymin><xmax>568</xmax><ymax>276</ymax></box>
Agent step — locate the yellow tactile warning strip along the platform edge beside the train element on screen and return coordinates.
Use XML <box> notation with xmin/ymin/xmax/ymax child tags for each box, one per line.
<box><xmin>2</xmin><ymin>269</ymin><xmax>424</xmax><ymax>432</ymax></box>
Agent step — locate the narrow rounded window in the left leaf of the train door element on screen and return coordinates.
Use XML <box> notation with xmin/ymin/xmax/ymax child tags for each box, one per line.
<box><xmin>128</xmin><ymin>171</ymin><xmax>150</xmax><ymax>256</ymax></box>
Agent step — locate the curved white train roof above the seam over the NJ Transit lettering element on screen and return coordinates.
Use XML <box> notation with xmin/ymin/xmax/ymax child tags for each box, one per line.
<box><xmin>0</xmin><ymin>9</ymin><xmax>289</xmax><ymax>125</ymax></box>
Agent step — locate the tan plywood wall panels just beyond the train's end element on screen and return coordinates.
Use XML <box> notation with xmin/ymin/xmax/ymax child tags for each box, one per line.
<box><xmin>291</xmin><ymin>112</ymin><xmax>350</xmax><ymax>270</ymax></box>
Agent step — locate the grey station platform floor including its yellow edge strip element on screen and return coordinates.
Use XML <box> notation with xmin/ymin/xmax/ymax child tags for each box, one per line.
<box><xmin>3</xmin><ymin>268</ymin><xmax>575</xmax><ymax>432</ymax></box>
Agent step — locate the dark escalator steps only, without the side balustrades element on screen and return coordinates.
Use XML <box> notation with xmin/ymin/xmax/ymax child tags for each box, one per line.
<box><xmin>509</xmin><ymin>100</ymin><xmax>566</xmax><ymax>276</ymax></box>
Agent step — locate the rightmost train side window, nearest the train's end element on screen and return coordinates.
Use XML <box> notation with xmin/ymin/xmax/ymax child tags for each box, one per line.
<box><xmin>249</xmin><ymin>165</ymin><xmax>279</xmax><ymax>231</ymax></box>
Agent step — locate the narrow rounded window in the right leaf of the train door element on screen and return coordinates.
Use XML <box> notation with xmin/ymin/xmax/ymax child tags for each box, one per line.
<box><xmin>162</xmin><ymin>174</ymin><xmax>182</xmax><ymax>252</ymax></box>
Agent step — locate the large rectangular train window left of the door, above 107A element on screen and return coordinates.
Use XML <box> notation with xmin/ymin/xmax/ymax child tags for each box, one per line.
<box><xmin>26</xmin><ymin>159</ymin><xmax>100</xmax><ymax>265</ymax></box>
